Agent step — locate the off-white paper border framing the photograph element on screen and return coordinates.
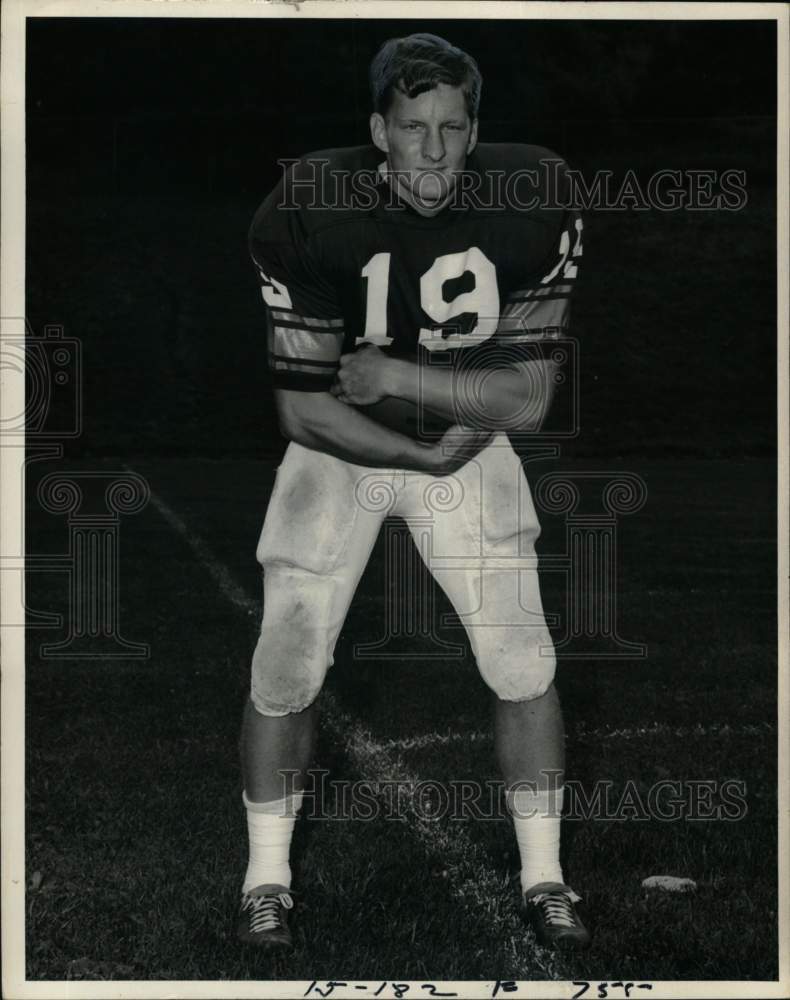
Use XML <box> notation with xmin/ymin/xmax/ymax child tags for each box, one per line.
<box><xmin>0</xmin><ymin>0</ymin><xmax>790</xmax><ymax>1000</ymax></box>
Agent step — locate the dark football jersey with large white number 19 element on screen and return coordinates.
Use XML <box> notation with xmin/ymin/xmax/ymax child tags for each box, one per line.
<box><xmin>250</xmin><ymin>144</ymin><xmax>582</xmax><ymax>422</ymax></box>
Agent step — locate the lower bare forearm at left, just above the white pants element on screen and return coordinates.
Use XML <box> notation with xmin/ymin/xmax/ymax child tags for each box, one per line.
<box><xmin>278</xmin><ymin>392</ymin><xmax>441</xmax><ymax>472</ymax></box>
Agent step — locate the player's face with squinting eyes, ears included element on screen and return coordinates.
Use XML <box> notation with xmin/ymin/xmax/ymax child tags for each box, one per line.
<box><xmin>370</xmin><ymin>83</ymin><xmax>477</xmax><ymax>215</ymax></box>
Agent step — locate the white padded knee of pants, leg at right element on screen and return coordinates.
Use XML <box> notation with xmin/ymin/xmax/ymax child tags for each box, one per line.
<box><xmin>475</xmin><ymin>626</ymin><xmax>557</xmax><ymax>701</ymax></box>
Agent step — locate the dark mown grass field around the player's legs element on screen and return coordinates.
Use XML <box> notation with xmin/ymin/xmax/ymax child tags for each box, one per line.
<box><xmin>26</xmin><ymin>456</ymin><xmax>777</xmax><ymax>980</ymax></box>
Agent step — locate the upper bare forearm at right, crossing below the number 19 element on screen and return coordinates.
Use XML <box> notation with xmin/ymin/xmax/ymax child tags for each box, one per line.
<box><xmin>388</xmin><ymin>359</ymin><xmax>553</xmax><ymax>431</ymax></box>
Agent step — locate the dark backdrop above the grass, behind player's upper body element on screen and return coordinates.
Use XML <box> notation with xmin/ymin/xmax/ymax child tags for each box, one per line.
<box><xmin>27</xmin><ymin>18</ymin><xmax>776</xmax><ymax>457</ymax></box>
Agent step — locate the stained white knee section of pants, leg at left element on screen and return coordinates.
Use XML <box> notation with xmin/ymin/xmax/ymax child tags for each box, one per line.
<box><xmin>250</xmin><ymin>565</ymin><xmax>337</xmax><ymax>716</ymax></box>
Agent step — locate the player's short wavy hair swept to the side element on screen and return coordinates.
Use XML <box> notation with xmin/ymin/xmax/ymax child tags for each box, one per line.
<box><xmin>370</xmin><ymin>32</ymin><xmax>483</xmax><ymax>121</ymax></box>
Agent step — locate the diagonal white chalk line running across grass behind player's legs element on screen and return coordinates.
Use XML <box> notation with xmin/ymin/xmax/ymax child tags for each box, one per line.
<box><xmin>141</xmin><ymin>480</ymin><xmax>565</xmax><ymax>979</ymax></box>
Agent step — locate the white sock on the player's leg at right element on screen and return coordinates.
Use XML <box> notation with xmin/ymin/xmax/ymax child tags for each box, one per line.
<box><xmin>507</xmin><ymin>787</ymin><xmax>565</xmax><ymax>892</ymax></box>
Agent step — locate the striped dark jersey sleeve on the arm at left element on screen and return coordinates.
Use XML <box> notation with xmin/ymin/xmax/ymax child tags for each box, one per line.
<box><xmin>250</xmin><ymin>182</ymin><xmax>345</xmax><ymax>392</ymax></box>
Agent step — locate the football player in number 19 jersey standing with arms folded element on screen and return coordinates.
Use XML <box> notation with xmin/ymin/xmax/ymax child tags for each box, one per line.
<box><xmin>238</xmin><ymin>33</ymin><xmax>589</xmax><ymax>948</ymax></box>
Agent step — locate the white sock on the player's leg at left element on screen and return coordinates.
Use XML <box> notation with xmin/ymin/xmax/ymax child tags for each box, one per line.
<box><xmin>241</xmin><ymin>792</ymin><xmax>303</xmax><ymax>892</ymax></box>
